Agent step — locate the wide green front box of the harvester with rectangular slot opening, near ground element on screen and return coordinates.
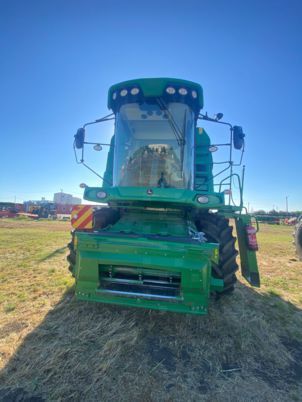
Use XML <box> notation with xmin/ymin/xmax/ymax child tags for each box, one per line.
<box><xmin>75</xmin><ymin>233</ymin><xmax>217</xmax><ymax>314</ymax></box>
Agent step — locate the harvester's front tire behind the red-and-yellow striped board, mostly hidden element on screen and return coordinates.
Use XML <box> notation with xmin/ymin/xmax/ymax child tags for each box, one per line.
<box><xmin>67</xmin><ymin>208</ymin><xmax>120</xmax><ymax>276</ymax></box>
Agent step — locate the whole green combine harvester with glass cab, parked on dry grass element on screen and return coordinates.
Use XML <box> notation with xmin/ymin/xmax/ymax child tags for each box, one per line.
<box><xmin>68</xmin><ymin>78</ymin><xmax>260</xmax><ymax>314</ymax></box>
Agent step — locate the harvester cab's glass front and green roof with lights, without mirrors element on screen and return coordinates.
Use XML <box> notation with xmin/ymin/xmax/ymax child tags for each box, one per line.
<box><xmin>108</xmin><ymin>79</ymin><xmax>201</xmax><ymax>189</ymax></box>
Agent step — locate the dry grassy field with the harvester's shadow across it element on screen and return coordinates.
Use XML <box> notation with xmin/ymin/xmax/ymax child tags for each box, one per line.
<box><xmin>0</xmin><ymin>219</ymin><xmax>302</xmax><ymax>402</ymax></box>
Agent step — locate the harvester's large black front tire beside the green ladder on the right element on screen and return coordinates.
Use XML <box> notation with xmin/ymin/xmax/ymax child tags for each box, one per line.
<box><xmin>196</xmin><ymin>213</ymin><xmax>238</xmax><ymax>294</ymax></box>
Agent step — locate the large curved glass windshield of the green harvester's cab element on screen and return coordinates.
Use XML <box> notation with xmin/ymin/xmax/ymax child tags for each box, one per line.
<box><xmin>113</xmin><ymin>102</ymin><xmax>194</xmax><ymax>188</ymax></box>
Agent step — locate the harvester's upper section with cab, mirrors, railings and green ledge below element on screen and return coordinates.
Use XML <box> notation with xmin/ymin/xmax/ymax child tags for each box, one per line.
<box><xmin>74</xmin><ymin>78</ymin><xmax>245</xmax><ymax>209</ymax></box>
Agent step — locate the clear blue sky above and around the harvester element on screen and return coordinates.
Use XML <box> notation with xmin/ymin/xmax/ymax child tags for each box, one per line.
<box><xmin>0</xmin><ymin>0</ymin><xmax>302</xmax><ymax>210</ymax></box>
